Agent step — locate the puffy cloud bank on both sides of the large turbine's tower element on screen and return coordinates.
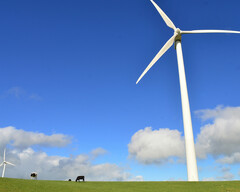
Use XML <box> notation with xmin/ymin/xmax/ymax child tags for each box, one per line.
<box><xmin>128</xmin><ymin>107</ymin><xmax>240</xmax><ymax>164</ymax></box>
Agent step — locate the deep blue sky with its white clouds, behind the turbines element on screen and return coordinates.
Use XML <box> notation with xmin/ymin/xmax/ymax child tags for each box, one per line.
<box><xmin>0</xmin><ymin>0</ymin><xmax>240</xmax><ymax>180</ymax></box>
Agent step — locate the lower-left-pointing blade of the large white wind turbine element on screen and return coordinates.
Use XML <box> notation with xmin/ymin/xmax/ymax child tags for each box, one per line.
<box><xmin>136</xmin><ymin>34</ymin><xmax>177</xmax><ymax>84</ymax></box>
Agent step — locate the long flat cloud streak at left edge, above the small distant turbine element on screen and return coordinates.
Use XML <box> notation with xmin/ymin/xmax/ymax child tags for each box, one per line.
<box><xmin>0</xmin><ymin>127</ymin><xmax>71</xmax><ymax>148</ymax></box>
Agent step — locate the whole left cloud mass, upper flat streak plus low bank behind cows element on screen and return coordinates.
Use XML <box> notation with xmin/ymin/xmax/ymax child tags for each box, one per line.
<box><xmin>0</xmin><ymin>127</ymin><xmax>143</xmax><ymax>181</ymax></box>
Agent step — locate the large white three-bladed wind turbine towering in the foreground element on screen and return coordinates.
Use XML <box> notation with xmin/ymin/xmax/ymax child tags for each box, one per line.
<box><xmin>136</xmin><ymin>0</ymin><xmax>240</xmax><ymax>181</ymax></box>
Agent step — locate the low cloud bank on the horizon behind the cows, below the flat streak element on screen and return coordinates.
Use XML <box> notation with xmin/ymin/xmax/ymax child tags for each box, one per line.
<box><xmin>1</xmin><ymin>148</ymin><xmax>140</xmax><ymax>181</ymax></box>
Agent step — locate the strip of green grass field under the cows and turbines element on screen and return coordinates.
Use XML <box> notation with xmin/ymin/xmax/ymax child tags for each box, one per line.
<box><xmin>0</xmin><ymin>178</ymin><xmax>240</xmax><ymax>192</ymax></box>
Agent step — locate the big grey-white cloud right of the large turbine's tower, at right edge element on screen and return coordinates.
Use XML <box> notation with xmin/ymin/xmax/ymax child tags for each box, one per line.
<box><xmin>196</xmin><ymin>107</ymin><xmax>240</xmax><ymax>160</ymax></box>
